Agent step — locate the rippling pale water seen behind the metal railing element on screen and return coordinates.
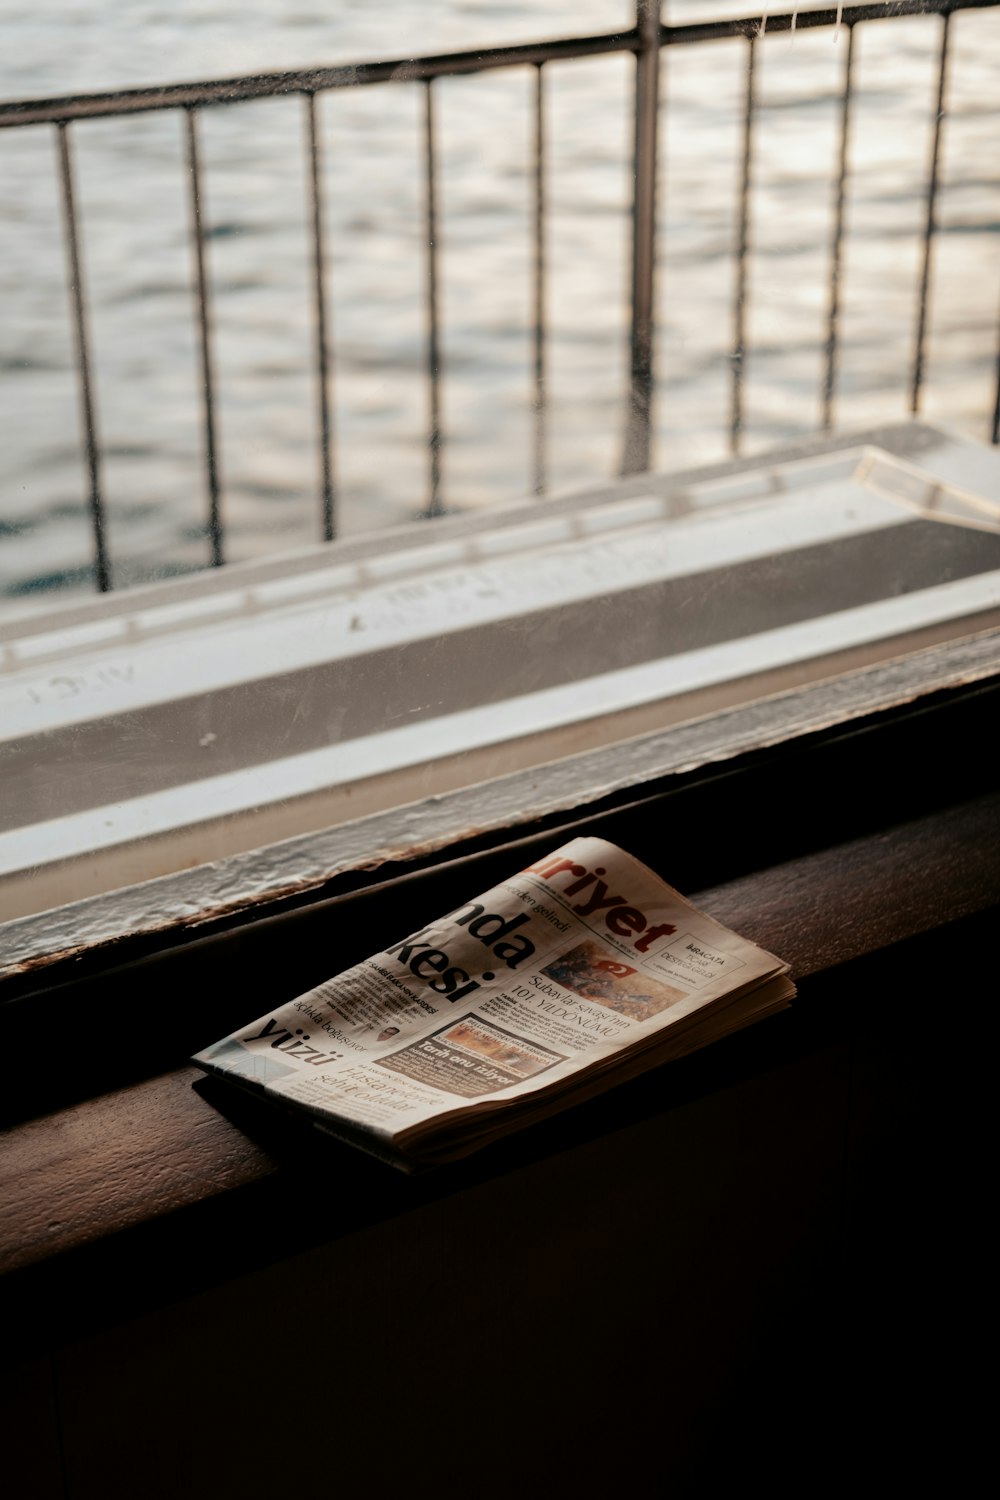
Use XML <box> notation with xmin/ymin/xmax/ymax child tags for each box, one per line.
<box><xmin>0</xmin><ymin>0</ymin><xmax>1000</xmax><ymax>606</ymax></box>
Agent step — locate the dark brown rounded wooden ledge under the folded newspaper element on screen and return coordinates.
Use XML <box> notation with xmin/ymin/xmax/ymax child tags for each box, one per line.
<box><xmin>0</xmin><ymin>794</ymin><xmax>1000</xmax><ymax>1362</ymax></box>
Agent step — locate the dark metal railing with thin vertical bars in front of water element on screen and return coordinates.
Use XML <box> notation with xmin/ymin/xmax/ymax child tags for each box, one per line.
<box><xmin>0</xmin><ymin>0</ymin><xmax>1000</xmax><ymax>591</ymax></box>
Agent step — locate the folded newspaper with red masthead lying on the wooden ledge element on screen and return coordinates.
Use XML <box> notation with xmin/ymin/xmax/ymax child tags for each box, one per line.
<box><xmin>193</xmin><ymin>839</ymin><xmax>795</xmax><ymax>1170</ymax></box>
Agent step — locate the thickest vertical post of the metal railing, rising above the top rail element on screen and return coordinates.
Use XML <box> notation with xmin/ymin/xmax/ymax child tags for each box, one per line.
<box><xmin>622</xmin><ymin>0</ymin><xmax>660</xmax><ymax>474</ymax></box>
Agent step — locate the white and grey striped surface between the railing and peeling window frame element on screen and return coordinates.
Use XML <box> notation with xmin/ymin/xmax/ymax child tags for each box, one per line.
<box><xmin>0</xmin><ymin>426</ymin><xmax>1000</xmax><ymax>915</ymax></box>
